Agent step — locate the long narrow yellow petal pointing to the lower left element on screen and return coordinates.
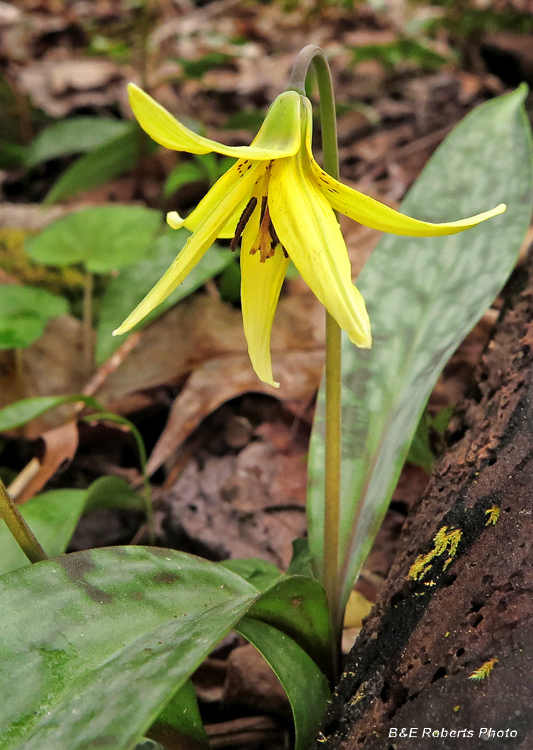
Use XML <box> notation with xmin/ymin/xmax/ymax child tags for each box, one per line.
<box><xmin>113</xmin><ymin>162</ymin><xmax>264</xmax><ymax>336</ymax></box>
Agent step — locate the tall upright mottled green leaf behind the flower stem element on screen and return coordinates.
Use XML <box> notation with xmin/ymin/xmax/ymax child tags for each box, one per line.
<box><xmin>308</xmin><ymin>87</ymin><xmax>532</xmax><ymax>602</ymax></box>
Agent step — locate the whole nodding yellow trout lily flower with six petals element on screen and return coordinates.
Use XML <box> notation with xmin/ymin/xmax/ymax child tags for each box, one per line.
<box><xmin>114</xmin><ymin>84</ymin><xmax>505</xmax><ymax>386</ymax></box>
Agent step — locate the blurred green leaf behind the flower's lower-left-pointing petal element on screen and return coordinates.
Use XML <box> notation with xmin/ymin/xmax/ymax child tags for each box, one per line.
<box><xmin>96</xmin><ymin>229</ymin><xmax>233</xmax><ymax>364</ymax></box>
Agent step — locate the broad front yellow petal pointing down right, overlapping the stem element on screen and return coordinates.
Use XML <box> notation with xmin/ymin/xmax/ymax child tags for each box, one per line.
<box><xmin>268</xmin><ymin>154</ymin><xmax>372</xmax><ymax>348</ymax></box>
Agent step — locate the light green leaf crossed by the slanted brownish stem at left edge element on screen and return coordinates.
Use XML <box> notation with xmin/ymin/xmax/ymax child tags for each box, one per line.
<box><xmin>0</xmin><ymin>490</ymin><xmax>87</xmax><ymax>575</ymax></box>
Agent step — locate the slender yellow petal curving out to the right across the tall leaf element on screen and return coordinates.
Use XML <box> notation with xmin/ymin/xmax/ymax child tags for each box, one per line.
<box><xmin>310</xmin><ymin>161</ymin><xmax>506</xmax><ymax>237</ymax></box>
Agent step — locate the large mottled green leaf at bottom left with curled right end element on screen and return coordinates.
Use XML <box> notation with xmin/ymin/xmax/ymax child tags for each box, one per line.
<box><xmin>0</xmin><ymin>546</ymin><xmax>329</xmax><ymax>750</ymax></box>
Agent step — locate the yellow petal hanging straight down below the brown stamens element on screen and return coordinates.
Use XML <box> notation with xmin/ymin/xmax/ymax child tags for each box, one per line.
<box><xmin>241</xmin><ymin>203</ymin><xmax>289</xmax><ymax>388</ymax></box>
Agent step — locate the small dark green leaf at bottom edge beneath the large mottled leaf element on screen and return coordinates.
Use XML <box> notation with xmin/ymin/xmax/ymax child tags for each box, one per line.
<box><xmin>149</xmin><ymin>680</ymin><xmax>209</xmax><ymax>750</ymax></box>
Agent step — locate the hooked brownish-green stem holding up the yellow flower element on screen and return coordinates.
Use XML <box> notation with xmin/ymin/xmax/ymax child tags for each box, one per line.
<box><xmin>288</xmin><ymin>44</ymin><xmax>343</xmax><ymax>675</ymax></box>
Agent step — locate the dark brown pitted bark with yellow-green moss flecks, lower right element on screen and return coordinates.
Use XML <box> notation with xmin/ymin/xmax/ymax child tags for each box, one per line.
<box><xmin>316</xmin><ymin>257</ymin><xmax>533</xmax><ymax>750</ymax></box>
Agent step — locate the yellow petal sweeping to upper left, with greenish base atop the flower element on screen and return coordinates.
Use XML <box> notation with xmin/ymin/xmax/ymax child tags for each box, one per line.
<box><xmin>128</xmin><ymin>83</ymin><xmax>300</xmax><ymax>160</ymax></box>
